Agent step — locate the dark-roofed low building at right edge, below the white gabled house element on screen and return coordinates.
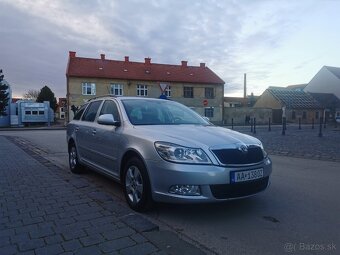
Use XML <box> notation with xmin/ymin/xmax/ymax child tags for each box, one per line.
<box><xmin>310</xmin><ymin>93</ymin><xmax>340</xmax><ymax>122</ymax></box>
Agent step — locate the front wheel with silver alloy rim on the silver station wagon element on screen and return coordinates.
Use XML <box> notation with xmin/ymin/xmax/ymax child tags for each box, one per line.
<box><xmin>123</xmin><ymin>157</ymin><xmax>153</xmax><ymax>212</ymax></box>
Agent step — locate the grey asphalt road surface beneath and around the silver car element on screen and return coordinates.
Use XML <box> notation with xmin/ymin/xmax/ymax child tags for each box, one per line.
<box><xmin>0</xmin><ymin>130</ymin><xmax>340</xmax><ymax>254</ymax></box>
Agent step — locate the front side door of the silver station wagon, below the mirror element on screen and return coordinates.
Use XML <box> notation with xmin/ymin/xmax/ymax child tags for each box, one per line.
<box><xmin>95</xmin><ymin>100</ymin><xmax>122</xmax><ymax>177</ymax></box>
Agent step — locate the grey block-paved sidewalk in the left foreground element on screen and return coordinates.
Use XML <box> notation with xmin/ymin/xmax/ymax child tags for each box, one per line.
<box><xmin>0</xmin><ymin>136</ymin><xmax>203</xmax><ymax>255</ymax></box>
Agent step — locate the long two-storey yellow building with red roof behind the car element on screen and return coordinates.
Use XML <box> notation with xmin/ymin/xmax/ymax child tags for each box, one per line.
<box><xmin>66</xmin><ymin>51</ymin><xmax>224</xmax><ymax>123</ymax></box>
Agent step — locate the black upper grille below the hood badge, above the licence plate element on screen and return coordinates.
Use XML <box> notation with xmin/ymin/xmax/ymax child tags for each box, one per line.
<box><xmin>212</xmin><ymin>146</ymin><xmax>263</xmax><ymax>165</ymax></box>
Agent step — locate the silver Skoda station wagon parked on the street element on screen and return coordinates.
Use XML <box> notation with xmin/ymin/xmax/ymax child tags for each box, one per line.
<box><xmin>67</xmin><ymin>96</ymin><xmax>272</xmax><ymax>211</ymax></box>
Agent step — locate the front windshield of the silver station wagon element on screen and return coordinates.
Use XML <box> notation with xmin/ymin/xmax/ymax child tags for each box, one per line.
<box><xmin>122</xmin><ymin>99</ymin><xmax>211</xmax><ymax>125</ymax></box>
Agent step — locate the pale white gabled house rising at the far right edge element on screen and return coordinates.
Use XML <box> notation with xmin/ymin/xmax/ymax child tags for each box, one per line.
<box><xmin>304</xmin><ymin>66</ymin><xmax>340</xmax><ymax>98</ymax></box>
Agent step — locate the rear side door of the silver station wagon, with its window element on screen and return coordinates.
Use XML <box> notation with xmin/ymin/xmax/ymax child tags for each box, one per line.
<box><xmin>76</xmin><ymin>100</ymin><xmax>103</xmax><ymax>164</ymax></box>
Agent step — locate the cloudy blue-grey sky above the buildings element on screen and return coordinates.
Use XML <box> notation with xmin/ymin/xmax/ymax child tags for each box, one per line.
<box><xmin>0</xmin><ymin>0</ymin><xmax>340</xmax><ymax>97</ymax></box>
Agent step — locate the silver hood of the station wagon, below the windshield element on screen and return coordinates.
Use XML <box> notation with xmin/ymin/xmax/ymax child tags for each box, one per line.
<box><xmin>133</xmin><ymin>125</ymin><xmax>261</xmax><ymax>149</ymax></box>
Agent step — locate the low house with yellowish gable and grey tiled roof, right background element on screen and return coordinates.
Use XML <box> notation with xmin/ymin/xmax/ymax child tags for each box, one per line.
<box><xmin>254</xmin><ymin>87</ymin><xmax>323</xmax><ymax>123</ymax></box>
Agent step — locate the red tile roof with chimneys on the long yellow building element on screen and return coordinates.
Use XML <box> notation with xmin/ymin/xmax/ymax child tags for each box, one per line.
<box><xmin>66</xmin><ymin>52</ymin><xmax>224</xmax><ymax>84</ymax></box>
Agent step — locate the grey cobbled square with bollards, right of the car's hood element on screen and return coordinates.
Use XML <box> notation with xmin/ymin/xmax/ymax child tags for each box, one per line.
<box><xmin>228</xmin><ymin>125</ymin><xmax>340</xmax><ymax>162</ymax></box>
